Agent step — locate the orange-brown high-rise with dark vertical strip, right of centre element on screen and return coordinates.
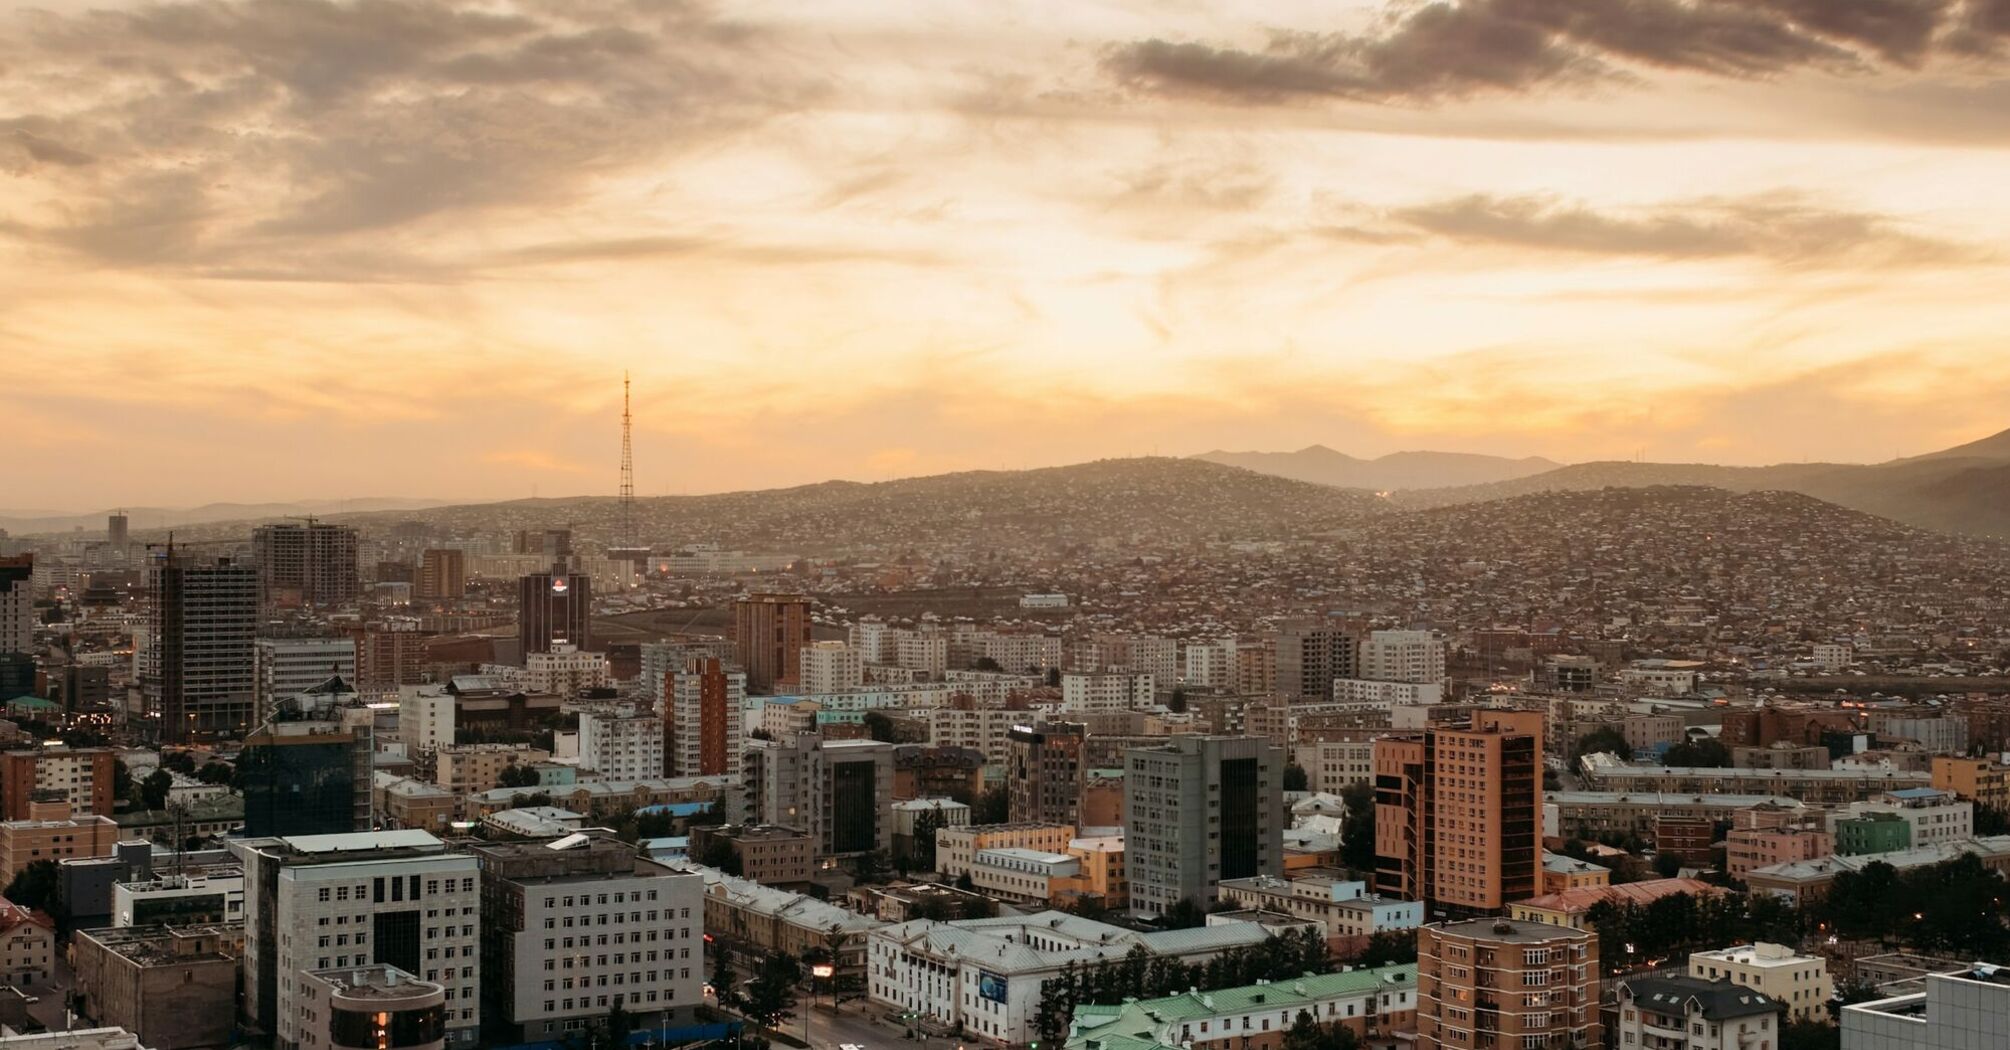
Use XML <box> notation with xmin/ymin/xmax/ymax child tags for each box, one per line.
<box><xmin>1375</xmin><ymin>710</ymin><xmax>1542</xmax><ymax>913</ymax></box>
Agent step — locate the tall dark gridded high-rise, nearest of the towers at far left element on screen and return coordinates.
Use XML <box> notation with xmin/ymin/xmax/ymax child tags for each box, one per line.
<box><xmin>143</xmin><ymin>549</ymin><xmax>259</xmax><ymax>744</ymax></box>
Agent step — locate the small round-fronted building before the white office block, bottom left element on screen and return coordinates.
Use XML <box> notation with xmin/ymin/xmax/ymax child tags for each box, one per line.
<box><xmin>295</xmin><ymin>964</ymin><xmax>456</xmax><ymax>1050</ymax></box>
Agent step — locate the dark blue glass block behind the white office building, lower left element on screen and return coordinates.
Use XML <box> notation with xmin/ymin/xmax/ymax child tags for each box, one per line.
<box><xmin>237</xmin><ymin>694</ymin><xmax>376</xmax><ymax>839</ymax></box>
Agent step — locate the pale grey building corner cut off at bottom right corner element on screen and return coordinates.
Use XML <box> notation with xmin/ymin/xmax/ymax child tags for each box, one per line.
<box><xmin>1843</xmin><ymin>964</ymin><xmax>2010</xmax><ymax>1050</ymax></box>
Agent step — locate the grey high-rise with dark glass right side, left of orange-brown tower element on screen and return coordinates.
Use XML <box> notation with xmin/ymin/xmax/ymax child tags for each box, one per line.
<box><xmin>1124</xmin><ymin>736</ymin><xmax>1284</xmax><ymax>915</ymax></box>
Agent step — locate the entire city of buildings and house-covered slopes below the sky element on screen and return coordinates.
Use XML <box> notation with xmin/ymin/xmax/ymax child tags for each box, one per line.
<box><xmin>0</xmin><ymin>480</ymin><xmax>2010</xmax><ymax>1050</ymax></box>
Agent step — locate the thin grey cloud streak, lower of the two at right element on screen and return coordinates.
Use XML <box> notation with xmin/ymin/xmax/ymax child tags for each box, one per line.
<box><xmin>1391</xmin><ymin>195</ymin><xmax>1984</xmax><ymax>266</ymax></box>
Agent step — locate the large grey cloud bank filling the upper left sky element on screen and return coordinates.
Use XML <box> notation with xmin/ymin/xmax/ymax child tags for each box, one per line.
<box><xmin>0</xmin><ymin>0</ymin><xmax>816</xmax><ymax>280</ymax></box>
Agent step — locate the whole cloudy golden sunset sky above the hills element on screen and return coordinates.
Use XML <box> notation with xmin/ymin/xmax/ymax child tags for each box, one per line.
<box><xmin>11</xmin><ymin>0</ymin><xmax>2010</xmax><ymax>509</ymax></box>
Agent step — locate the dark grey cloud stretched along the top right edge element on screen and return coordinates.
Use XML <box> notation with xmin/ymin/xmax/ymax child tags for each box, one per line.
<box><xmin>1103</xmin><ymin>0</ymin><xmax>2010</xmax><ymax>103</ymax></box>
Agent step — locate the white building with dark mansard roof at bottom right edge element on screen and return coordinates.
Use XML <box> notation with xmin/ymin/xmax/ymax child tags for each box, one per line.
<box><xmin>1614</xmin><ymin>976</ymin><xmax>1783</xmax><ymax>1050</ymax></box>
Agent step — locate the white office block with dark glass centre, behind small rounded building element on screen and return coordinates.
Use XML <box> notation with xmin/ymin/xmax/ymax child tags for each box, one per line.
<box><xmin>229</xmin><ymin>831</ymin><xmax>480</xmax><ymax>1050</ymax></box>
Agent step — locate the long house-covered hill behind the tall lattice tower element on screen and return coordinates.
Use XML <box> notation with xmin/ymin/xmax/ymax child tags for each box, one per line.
<box><xmin>309</xmin><ymin>459</ymin><xmax>1387</xmax><ymax>557</ymax></box>
